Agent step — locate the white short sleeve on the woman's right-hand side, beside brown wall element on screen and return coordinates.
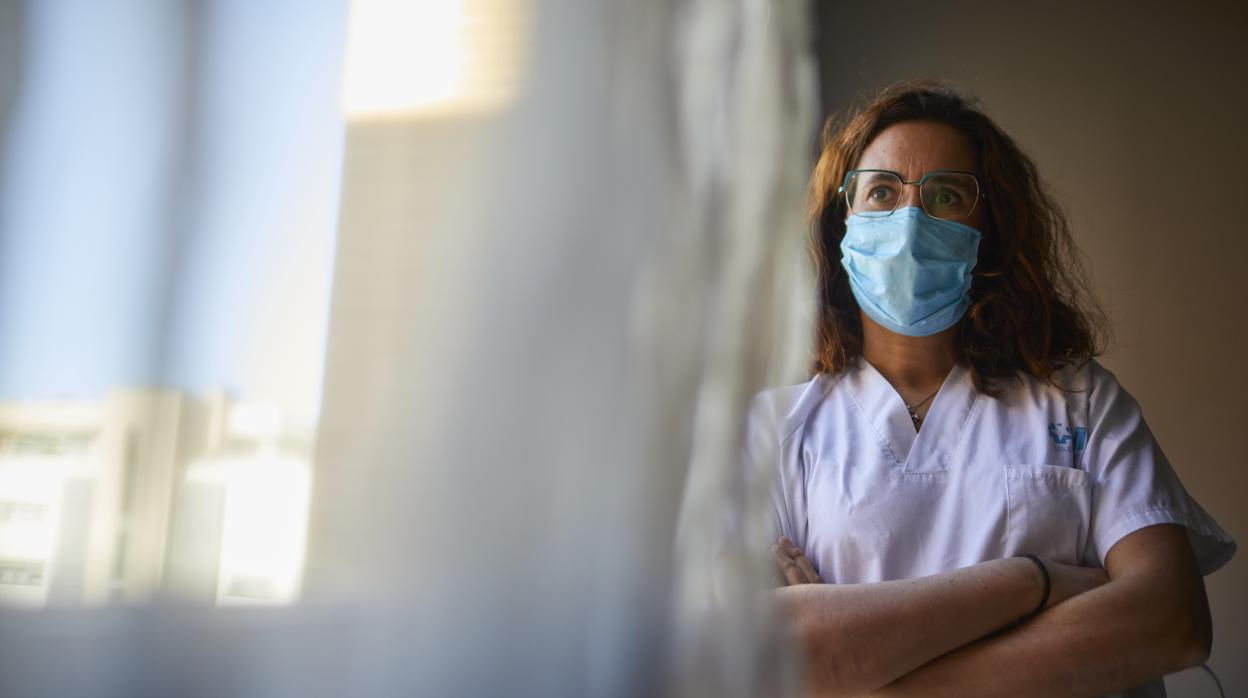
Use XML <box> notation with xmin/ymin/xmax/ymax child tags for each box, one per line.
<box><xmin>1083</xmin><ymin>361</ymin><xmax>1236</xmax><ymax>574</ymax></box>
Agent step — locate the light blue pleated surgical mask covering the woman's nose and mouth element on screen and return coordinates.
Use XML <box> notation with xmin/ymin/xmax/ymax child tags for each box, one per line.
<box><xmin>841</xmin><ymin>206</ymin><xmax>980</xmax><ymax>337</ymax></box>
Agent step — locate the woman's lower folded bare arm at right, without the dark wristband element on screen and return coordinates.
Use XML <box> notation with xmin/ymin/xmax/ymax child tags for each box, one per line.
<box><xmin>858</xmin><ymin>524</ymin><xmax>1212</xmax><ymax>698</ymax></box>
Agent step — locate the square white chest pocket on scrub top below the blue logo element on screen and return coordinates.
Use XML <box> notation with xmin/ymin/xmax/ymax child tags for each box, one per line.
<box><xmin>1005</xmin><ymin>465</ymin><xmax>1092</xmax><ymax>564</ymax></box>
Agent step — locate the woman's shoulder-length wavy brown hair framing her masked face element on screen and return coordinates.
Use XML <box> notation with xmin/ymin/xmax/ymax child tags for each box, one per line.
<box><xmin>807</xmin><ymin>80</ymin><xmax>1107</xmax><ymax>396</ymax></box>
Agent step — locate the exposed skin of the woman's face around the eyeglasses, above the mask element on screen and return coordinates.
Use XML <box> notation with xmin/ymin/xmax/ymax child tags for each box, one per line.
<box><xmin>855</xmin><ymin>121</ymin><xmax>985</xmax><ymax>232</ymax></box>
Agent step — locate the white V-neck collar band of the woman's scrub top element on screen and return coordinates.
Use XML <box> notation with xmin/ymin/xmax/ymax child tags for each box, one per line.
<box><xmin>845</xmin><ymin>357</ymin><xmax>980</xmax><ymax>472</ymax></box>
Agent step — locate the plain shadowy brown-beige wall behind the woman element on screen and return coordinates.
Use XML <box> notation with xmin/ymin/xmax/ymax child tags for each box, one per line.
<box><xmin>815</xmin><ymin>0</ymin><xmax>1248</xmax><ymax>696</ymax></box>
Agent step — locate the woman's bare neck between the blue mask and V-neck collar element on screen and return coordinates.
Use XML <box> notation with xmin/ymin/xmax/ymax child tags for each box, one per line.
<box><xmin>862</xmin><ymin>315</ymin><xmax>958</xmax><ymax>398</ymax></box>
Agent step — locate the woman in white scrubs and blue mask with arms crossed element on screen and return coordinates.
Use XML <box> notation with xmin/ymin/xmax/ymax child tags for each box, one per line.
<box><xmin>748</xmin><ymin>82</ymin><xmax>1236</xmax><ymax>698</ymax></box>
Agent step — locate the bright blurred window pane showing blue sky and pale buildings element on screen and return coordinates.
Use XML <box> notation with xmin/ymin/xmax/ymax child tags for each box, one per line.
<box><xmin>0</xmin><ymin>0</ymin><xmax>347</xmax><ymax>607</ymax></box>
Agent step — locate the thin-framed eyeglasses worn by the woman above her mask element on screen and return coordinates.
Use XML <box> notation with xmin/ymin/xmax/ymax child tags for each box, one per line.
<box><xmin>837</xmin><ymin>170</ymin><xmax>981</xmax><ymax>221</ymax></box>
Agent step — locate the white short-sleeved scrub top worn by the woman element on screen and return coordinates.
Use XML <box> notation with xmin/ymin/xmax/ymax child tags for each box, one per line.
<box><xmin>746</xmin><ymin>358</ymin><xmax>1236</xmax><ymax>583</ymax></box>
